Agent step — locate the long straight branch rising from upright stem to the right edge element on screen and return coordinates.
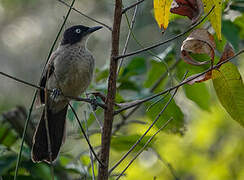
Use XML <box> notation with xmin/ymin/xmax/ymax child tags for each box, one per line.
<box><xmin>114</xmin><ymin>49</ymin><xmax>244</xmax><ymax>115</ymax></box>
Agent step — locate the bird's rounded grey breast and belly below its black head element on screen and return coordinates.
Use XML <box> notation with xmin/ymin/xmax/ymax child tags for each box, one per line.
<box><xmin>51</xmin><ymin>46</ymin><xmax>94</xmax><ymax>96</ymax></box>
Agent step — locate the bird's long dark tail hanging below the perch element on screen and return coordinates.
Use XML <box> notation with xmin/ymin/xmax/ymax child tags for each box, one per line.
<box><xmin>31</xmin><ymin>105</ymin><xmax>68</xmax><ymax>163</ymax></box>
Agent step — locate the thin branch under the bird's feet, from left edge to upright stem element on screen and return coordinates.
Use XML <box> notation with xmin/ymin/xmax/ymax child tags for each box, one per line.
<box><xmin>0</xmin><ymin>72</ymin><xmax>106</xmax><ymax>109</ymax></box>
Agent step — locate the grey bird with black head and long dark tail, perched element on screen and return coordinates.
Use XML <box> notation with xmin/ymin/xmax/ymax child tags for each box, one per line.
<box><xmin>31</xmin><ymin>25</ymin><xmax>102</xmax><ymax>164</ymax></box>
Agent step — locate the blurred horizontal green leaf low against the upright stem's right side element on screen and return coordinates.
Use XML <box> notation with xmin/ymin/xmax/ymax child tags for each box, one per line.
<box><xmin>111</xmin><ymin>134</ymin><xmax>154</xmax><ymax>151</ymax></box>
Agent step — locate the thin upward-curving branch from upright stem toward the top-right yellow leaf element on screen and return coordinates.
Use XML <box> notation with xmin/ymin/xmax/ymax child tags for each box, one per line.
<box><xmin>115</xmin><ymin>6</ymin><xmax>215</xmax><ymax>60</ymax></box>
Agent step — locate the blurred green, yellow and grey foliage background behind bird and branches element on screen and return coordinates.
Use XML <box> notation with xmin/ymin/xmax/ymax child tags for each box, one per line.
<box><xmin>0</xmin><ymin>0</ymin><xmax>244</xmax><ymax>180</ymax></box>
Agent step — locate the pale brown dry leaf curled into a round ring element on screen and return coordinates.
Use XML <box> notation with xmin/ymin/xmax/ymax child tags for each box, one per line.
<box><xmin>181</xmin><ymin>29</ymin><xmax>216</xmax><ymax>66</ymax></box>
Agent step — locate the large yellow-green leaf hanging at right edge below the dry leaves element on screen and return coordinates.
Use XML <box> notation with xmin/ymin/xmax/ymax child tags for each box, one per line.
<box><xmin>213</xmin><ymin>63</ymin><xmax>244</xmax><ymax>127</ymax></box>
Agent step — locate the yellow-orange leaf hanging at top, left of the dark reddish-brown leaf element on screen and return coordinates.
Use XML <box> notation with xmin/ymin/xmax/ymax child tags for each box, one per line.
<box><xmin>153</xmin><ymin>0</ymin><xmax>173</xmax><ymax>30</ymax></box>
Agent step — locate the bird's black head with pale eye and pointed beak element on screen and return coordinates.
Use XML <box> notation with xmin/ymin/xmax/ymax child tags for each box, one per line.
<box><xmin>61</xmin><ymin>25</ymin><xmax>102</xmax><ymax>45</ymax></box>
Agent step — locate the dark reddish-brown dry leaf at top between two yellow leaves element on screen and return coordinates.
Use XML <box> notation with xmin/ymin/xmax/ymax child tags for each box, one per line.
<box><xmin>170</xmin><ymin>0</ymin><xmax>203</xmax><ymax>24</ymax></box>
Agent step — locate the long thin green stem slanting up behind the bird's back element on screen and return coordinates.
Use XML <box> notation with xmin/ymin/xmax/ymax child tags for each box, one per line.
<box><xmin>14</xmin><ymin>0</ymin><xmax>75</xmax><ymax>180</ymax></box>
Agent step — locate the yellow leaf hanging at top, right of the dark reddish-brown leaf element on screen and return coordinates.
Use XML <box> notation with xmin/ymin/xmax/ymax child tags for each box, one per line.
<box><xmin>202</xmin><ymin>0</ymin><xmax>222</xmax><ymax>40</ymax></box>
